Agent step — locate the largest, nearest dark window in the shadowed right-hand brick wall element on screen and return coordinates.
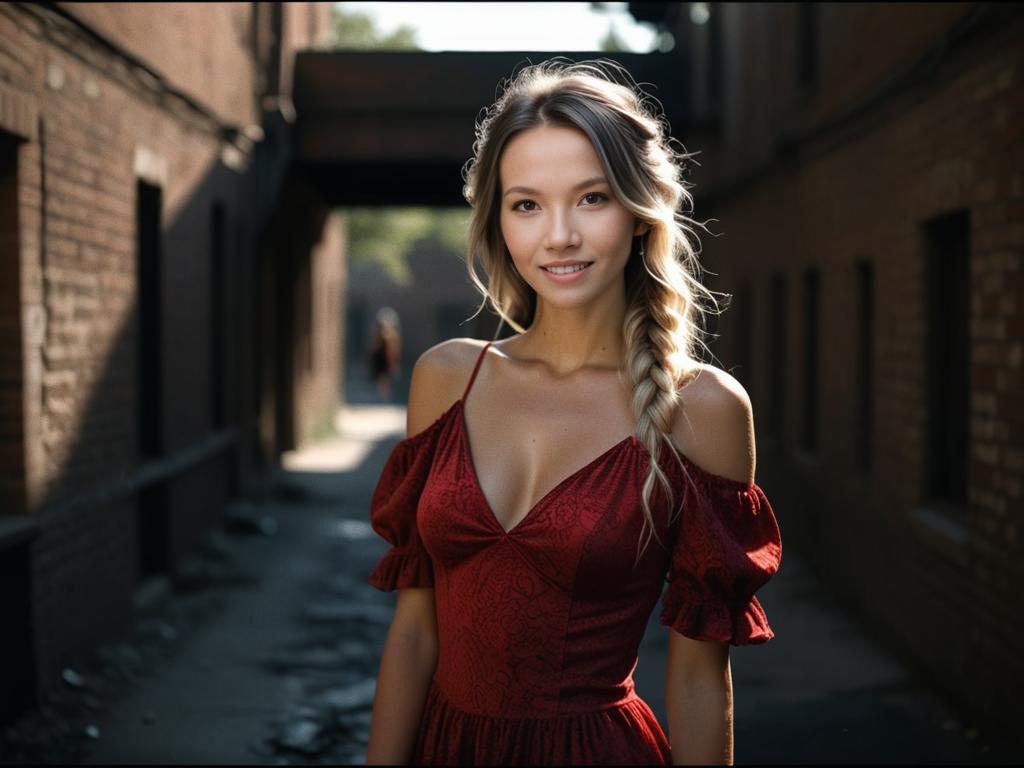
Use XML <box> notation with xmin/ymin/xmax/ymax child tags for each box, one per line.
<box><xmin>925</xmin><ymin>211</ymin><xmax>971</xmax><ymax>509</ymax></box>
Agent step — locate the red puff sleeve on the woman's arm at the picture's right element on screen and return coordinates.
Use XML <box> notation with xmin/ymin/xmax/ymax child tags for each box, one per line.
<box><xmin>660</xmin><ymin>463</ymin><xmax>782</xmax><ymax>645</ymax></box>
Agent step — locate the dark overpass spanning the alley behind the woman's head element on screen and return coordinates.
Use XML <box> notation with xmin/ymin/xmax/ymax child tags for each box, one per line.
<box><xmin>294</xmin><ymin>51</ymin><xmax>689</xmax><ymax>206</ymax></box>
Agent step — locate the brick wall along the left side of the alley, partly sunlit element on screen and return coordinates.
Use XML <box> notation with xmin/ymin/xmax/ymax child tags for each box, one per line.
<box><xmin>0</xmin><ymin>3</ymin><xmax>340</xmax><ymax>704</ymax></box>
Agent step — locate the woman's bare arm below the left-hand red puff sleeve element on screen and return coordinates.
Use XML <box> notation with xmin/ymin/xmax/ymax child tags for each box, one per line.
<box><xmin>367</xmin><ymin>589</ymin><xmax>437</xmax><ymax>765</ymax></box>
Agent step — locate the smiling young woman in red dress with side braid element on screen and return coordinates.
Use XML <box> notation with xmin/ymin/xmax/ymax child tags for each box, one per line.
<box><xmin>368</xmin><ymin>62</ymin><xmax>781</xmax><ymax>765</ymax></box>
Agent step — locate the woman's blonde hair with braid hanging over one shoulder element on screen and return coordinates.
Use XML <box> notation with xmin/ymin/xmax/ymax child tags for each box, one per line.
<box><xmin>463</xmin><ymin>59</ymin><xmax>718</xmax><ymax>558</ymax></box>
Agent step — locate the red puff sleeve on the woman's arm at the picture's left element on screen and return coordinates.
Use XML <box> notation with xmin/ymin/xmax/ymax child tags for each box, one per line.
<box><xmin>368</xmin><ymin>428</ymin><xmax>437</xmax><ymax>592</ymax></box>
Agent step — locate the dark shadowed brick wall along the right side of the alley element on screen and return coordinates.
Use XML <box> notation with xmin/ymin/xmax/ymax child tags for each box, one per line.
<box><xmin>694</xmin><ymin>5</ymin><xmax>1024</xmax><ymax>741</ymax></box>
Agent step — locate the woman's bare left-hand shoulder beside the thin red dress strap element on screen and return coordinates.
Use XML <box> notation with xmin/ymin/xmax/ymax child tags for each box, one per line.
<box><xmin>406</xmin><ymin>338</ymin><xmax>486</xmax><ymax>436</ymax></box>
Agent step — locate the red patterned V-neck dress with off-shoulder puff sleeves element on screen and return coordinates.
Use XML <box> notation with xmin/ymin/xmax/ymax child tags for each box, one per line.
<box><xmin>370</xmin><ymin>346</ymin><xmax>781</xmax><ymax>765</ymax></box>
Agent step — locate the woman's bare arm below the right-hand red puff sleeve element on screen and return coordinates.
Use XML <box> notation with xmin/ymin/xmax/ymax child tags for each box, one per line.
<box><xmin>665</xmin><ymin>630</ymin><xmax>732</xmax><ymax>765</ymax></box>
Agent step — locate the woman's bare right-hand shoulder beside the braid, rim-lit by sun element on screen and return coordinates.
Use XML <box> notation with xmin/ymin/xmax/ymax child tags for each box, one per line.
<box><xmin>673</xmin><ymin>364</ymin><xmax>757</xmax><ymax>482</ymax></box>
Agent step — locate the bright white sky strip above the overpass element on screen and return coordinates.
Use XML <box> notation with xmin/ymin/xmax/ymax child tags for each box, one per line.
<box><xmin>337</xmin><ymin>2</ymin><xmax>654</xmax><ymax>52</ymax></box>
